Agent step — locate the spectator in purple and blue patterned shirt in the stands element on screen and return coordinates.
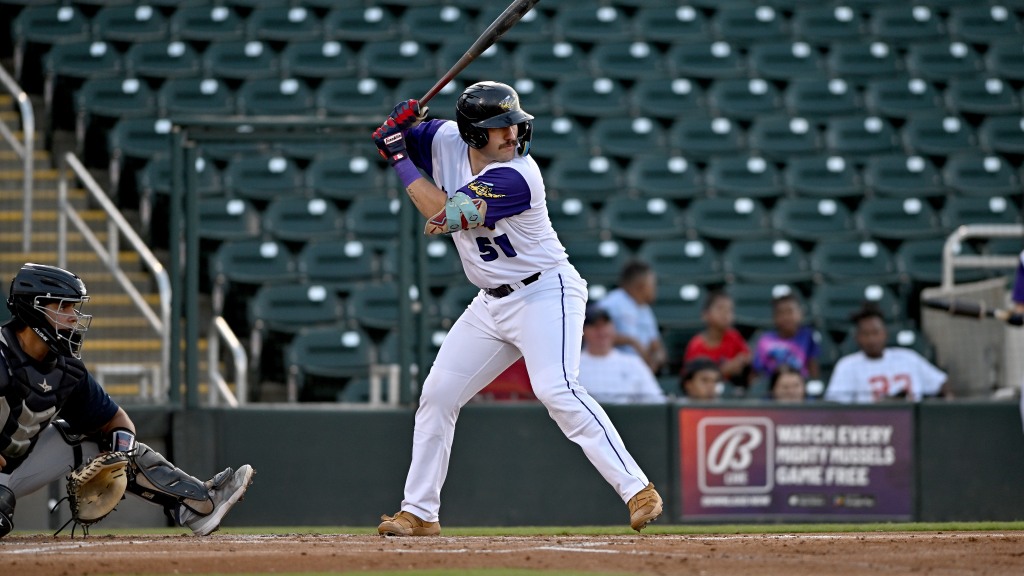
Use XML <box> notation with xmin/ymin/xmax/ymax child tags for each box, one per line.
<box><xmin>754</xmin><ymin>292</ymin><xmax>819</xmax><ymax>382</ymax></box>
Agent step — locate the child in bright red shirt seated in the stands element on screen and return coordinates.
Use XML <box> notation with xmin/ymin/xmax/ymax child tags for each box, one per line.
<box><xmin>683</xmin><ymin>290</ymin><xmax>753</xmax><ymax>388</ymax></box>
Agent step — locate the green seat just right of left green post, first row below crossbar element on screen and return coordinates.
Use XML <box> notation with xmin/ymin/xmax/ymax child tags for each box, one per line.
<box><xmin>224</xmin><ymin>154</ymin><xmax>303</xmax><ymax>202</ymax></box>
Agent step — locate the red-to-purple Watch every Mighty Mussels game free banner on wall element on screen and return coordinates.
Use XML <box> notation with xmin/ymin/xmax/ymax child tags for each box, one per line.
<box><xmin>679</xmin><ymin>406</ymin><xmax>913</xmax><ymax>521</ymax></box>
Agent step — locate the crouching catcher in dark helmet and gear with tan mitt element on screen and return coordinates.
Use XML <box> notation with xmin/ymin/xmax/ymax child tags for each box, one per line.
<box><xmin>0</xmin><ymin>263</ymin><xmax>255</xmax><ymax>538</ymax></box>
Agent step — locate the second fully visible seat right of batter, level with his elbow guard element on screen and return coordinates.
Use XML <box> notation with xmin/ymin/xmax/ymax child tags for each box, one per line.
<box><xmin>685</xmin><ymin>198</ymin><xmax>771</xmax><ymax>241</ymax></box>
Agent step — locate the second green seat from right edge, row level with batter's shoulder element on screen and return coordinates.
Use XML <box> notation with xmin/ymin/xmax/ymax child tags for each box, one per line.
<box><xmin>864</xmin><ymin>154</ymin><xmax>946</xmax><ymax>198</ymax></box>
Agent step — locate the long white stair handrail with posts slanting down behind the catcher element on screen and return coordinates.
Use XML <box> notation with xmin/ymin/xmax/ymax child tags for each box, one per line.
<box><xmin>57</xmin><ymin>153</ymin><xmax>171</xmax><ymax>399</ymax></box>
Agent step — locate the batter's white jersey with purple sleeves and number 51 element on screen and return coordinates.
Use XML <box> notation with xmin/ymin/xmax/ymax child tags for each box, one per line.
<box><xmin>406</xmin><ymin>120</ymin><xmax>568</xmax><ymax>288</ymax></box>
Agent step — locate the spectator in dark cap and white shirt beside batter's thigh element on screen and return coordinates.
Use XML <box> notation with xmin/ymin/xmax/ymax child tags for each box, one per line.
<box><xmin>580</xmin><ymin>304</ymin><xmax>666</xmax><ymax>404</ymax></box>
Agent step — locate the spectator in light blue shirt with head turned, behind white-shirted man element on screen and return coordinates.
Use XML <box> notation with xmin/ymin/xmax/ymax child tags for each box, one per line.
<box><xmin>600</xmin><ymin>260</ymin><xmax>665</xmax><ymax>374</ymax></box>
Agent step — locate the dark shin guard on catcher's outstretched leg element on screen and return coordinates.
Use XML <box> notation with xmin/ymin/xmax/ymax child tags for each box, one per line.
<box><xmin>128</xmin><ymin>442</ymin><xmax>213</xmax><ymax>513</ymax></box>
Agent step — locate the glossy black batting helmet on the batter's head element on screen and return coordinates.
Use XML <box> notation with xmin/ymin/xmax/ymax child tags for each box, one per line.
<box><xmin>455</xmin><ymin>82</ymin><xmax>534</xmax><ymax>156</ymax></box>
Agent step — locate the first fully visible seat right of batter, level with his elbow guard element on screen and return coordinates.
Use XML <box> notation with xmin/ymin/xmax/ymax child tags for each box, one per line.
<box><xmin>600</xmin><ymin>195</ymin><xmax>683</xmax><ymax>240</ymax></box>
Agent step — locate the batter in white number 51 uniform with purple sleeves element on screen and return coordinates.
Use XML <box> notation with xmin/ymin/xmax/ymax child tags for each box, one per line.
<box><xmin>373</xmin><ymin>82</ymin><xmax>663</xmax><ymax>536</ymax></box>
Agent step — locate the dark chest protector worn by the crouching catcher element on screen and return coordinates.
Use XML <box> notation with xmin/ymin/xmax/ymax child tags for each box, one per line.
<box><xmin>0</xmin><ymin>328</ymin><xmax>86</xmax><ymax>474</ymax></box>
